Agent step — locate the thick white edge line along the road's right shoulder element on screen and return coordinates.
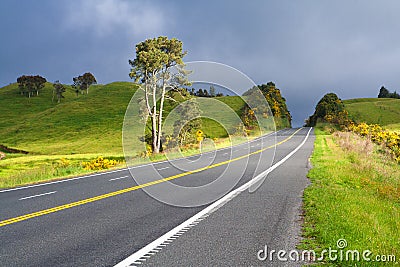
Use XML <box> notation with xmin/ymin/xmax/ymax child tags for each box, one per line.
<box><xmin>114</xmin><ymin>127</ymin><xmax>312</xmax><ymax>267</ymax></box>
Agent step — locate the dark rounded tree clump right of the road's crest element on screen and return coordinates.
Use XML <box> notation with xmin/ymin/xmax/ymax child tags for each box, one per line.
<box><xmin>306</xmin><ymin>93</ymin><xmax>349</xmax><ymax>127</ymax></box>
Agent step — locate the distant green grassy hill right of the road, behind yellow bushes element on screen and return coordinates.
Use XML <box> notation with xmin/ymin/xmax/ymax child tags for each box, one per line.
<box><xmin>343</xmin><ymin>98</ymin><xmax>400</xmax><ymax>130</ymax></box>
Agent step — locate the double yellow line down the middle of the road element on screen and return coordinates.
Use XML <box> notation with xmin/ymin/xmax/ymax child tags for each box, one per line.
<box><xmin>0</xmin><ymin>128</ymin><xmax>302</xmax><ymax>227</ymax></box>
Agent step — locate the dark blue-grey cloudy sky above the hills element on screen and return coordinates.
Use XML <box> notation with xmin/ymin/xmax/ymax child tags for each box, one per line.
<box><xmin>0</xmin><ymin>0</ymin><xmax>400</xmax><ymax>126</ymax></box>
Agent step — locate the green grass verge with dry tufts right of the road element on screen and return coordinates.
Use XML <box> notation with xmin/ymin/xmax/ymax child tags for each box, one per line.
<box><xmin>300</xmin><ymin>129</ymin><xmax>400</xmax><ymax>266</ymax></box>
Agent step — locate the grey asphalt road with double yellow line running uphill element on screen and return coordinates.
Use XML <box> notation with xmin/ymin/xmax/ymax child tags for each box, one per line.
<box><xmin>0</xmin><ymin>128</ymin><xmax>314</xmax><ymax>266</ymax></box>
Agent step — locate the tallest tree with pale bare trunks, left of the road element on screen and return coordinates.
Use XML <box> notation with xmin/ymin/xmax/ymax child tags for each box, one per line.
<box><xmin>129</xmin><ymin>36</ymin><xmax>190</xmax><ymax>153</ymax></box>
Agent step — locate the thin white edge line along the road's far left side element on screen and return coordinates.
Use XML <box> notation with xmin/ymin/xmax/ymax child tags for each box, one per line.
<box><xmin>0</xmin><ymin>128</ymin><xmax>287</xmax><ymax>193</ymax></box>
